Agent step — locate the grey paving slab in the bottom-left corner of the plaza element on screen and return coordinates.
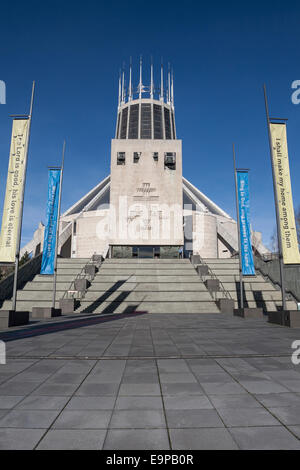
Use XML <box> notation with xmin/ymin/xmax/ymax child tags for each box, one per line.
<box><xmin>0</xmin><ymin>428</ymin><xmax>47</xmax><ymax>450</ymax></box>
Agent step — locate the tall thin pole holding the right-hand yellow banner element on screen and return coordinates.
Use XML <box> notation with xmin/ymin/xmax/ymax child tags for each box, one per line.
<box><xmin>264</xmin><ymin>85</ymin><xmax>286</xmax><ymax>310</ymax></box>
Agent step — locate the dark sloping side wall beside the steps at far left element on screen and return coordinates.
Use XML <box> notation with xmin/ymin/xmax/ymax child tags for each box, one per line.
<box><xmin>0</xmin><ymin>253</ymin><xmax>42</xmax><ymax>306</ymax></box>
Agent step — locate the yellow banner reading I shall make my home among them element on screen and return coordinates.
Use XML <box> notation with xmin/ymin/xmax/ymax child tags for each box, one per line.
<box><xmin>270</xmin><ymin>123</ymin><xmax>300</xmax><ymax>264</ymax></box>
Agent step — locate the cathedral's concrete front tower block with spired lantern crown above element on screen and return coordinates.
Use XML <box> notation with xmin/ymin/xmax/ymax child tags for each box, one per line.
<box><xmin>110</xmin><ymin>59</ymin><xmax>183</xmax><ymax>257</ymax></box>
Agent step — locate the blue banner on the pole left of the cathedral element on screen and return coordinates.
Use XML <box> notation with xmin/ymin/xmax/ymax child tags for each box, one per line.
<box><xmin>41</xmin><ymin>169</ymin><xmax>60</xmax><ymax>274</ymax></box>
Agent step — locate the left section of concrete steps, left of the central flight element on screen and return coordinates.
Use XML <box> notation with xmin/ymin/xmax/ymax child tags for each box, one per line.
<box><xmin>1</xmin><ymin>258</ymin><xmax>89</xmax><ymax>312</ymax></box>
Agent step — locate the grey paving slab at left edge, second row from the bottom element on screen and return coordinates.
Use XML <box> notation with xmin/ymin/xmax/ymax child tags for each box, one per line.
<box><xmin>0</xmin><ymin>410</ymin><xmax>59</xmax><ymax>429</ymax></box>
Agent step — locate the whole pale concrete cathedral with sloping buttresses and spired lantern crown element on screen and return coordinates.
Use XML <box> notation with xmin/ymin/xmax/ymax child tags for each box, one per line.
<box><xmin>21</xmin><ymin>63</ymin><xmax>267</xmax><ymax>258</ymax></box>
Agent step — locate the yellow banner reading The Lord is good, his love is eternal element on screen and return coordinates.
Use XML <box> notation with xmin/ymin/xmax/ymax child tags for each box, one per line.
<box><xmin>0</xmin><ymin>119</ymin><xmax>29</xmax><ymax>263</ymax></box>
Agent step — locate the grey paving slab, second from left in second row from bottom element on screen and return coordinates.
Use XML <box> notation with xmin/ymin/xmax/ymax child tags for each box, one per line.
<box><xmin>52</xmin><ymin>410</ymin><xmax>111</xmax><ymax>429</ymax></box>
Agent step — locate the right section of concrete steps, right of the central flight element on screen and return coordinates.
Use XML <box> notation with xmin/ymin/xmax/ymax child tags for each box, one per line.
<box><xmin>203</xmin><ymin>258</ymin><xmax>297</xmax><ymax>312</ymax></box>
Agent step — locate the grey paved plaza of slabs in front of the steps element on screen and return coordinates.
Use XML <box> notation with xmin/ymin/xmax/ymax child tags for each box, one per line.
<box><xmin>0</xmin><ymin>313</ymin><xmax>300</xmax><ymax>450</ymax></box>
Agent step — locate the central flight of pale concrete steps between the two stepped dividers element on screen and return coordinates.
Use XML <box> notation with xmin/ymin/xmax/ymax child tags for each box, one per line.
<box><xmin>78</xmin><ymin>258</ymin><xmax>219</xmax><ymax>313</ymax></box>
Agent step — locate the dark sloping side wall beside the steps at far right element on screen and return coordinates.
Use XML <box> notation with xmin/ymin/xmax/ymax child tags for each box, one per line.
<box><xmin>255</xmin><ymin>256</ymin><xmax>300</xmax><ymax>302</ymax></box>
